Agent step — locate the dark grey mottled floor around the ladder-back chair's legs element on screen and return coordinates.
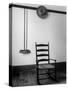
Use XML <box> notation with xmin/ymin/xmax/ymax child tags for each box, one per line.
<box><xmin>12</xmin><ymin>69</ymin><xmax>66</xmax><ymax>86</ymax></box>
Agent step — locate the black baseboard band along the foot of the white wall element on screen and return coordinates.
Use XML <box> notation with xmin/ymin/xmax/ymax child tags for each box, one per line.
<box><xmin>9</xmin><ymin>62</ymin><xmax>66</xmax><ymax>87</ymax></box>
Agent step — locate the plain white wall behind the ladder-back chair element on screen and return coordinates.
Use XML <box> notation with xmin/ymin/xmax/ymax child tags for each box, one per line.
<box><xmin>12</xmin><ymin>6</ymin><xmax>66</xmax><ymax>66</ymax></box>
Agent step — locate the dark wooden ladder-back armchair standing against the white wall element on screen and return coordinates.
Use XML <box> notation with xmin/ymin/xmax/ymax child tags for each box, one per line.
<box><xmin>35</xmin><ymin>43</ymin><xmax>56</xmax><ymax>85</ymax></box>
